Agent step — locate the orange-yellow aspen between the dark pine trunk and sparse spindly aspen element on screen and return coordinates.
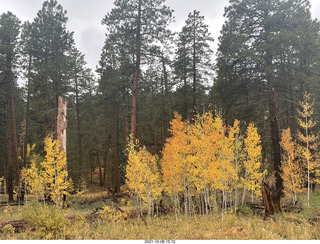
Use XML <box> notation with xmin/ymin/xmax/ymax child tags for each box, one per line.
<box><xmin>280</xmin><ymin>128</ymin><xmax>303</xmax><ymax>203</ymax></box>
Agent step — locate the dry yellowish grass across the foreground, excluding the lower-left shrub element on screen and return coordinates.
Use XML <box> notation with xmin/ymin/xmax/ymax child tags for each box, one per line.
<box><xmin>0</xmin><ymin>190</ymin><xmax>320</xmax><ymax>240</ymax></box>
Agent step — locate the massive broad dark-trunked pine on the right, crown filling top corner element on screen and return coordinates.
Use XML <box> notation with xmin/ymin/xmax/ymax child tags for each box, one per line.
<box><xmin>212</xmin><ymin>0</ymin><xmax>318</xmax><ymax>208</ymax></box>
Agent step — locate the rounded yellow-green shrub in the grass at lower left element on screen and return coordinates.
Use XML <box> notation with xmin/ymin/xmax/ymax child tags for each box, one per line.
<box><xmin>23</xmin><ymin>201</ymin><xmax>66</xmax><ymax>236</ymax></box>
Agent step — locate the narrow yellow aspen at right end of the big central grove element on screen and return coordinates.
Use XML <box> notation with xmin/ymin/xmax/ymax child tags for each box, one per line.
<box><xmin>242</xmin><ymin>123</ymin><xmax>265</xmax><ymax>203</ymax></box>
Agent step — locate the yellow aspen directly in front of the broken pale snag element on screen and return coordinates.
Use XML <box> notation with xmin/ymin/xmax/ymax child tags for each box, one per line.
<box><xmin>41</xmin><ymin>136</ymin><xmax>68</xmax><ymax>206</ymax></box>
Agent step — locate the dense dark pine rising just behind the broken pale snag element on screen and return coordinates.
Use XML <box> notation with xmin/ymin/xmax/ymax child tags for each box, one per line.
<box><xmin>30</xmin><ymin>0</ymin><xmax>73</xmax><ymax>142</ymax></box>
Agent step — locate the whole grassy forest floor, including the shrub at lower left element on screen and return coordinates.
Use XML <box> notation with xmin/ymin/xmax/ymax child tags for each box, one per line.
<box><xmin>0</xmin><ymin>186</ymin><xmax>320</xmax><ymax>240</ymax></box>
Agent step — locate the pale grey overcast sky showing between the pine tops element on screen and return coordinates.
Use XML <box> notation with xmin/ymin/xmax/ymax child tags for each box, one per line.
<box><xmin>0</xmin><ymin>0</ymin><xmax>320</xmax><ymax>70</ymax></box>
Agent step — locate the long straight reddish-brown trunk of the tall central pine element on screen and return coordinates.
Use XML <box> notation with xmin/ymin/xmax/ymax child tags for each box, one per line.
<box><xmin>131</xmin><ymin>0</ymin><xmax>142</xmax><ymax>137</ymax></box>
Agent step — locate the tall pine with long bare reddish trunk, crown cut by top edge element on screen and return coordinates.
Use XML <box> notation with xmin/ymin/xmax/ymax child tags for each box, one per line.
<box><xmin>102</xmin><ymin>0</ymin><xmax>172</xmax><ymax>136</ymax></box>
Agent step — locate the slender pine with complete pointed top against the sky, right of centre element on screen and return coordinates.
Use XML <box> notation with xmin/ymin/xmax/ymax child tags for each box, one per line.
<box><xmin>175</xmin><ymin>10</ymin><xmax>213</xmax><ymax>118</ymax></box>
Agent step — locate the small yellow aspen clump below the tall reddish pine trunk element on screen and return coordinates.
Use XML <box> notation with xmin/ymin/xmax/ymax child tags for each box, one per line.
<box><xmin>126</xmin><ymin>137</ymin><xmax>162</xmax><ymax>216</ymax></box>
